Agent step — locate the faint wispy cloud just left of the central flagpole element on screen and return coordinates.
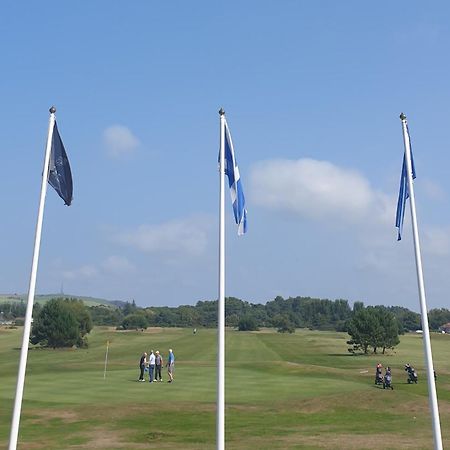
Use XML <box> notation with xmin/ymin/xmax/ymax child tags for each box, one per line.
<box><xmin>115</xmin><ymin>216</ymin><xmax>211</xmax><ymax>255</ymax></box>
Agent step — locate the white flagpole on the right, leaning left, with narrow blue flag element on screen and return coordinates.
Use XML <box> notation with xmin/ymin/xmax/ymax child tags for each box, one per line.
<box><xmin>400</xmin><ymin>113</ymin><xmax>442</xmax><ymax>450</ymax></box>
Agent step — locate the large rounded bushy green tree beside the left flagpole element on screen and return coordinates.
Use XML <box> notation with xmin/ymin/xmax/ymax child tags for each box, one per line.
<box><xmin>30</xmin><ymin>298</ymin><xmax>83</xmax><ymax>348</ymax></box>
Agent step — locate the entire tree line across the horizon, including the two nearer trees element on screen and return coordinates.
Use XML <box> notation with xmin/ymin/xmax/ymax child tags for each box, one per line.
<box><xmin>0</xmin><ymin>296</ymin><xmax>450</xmax><ymax>353</ymax></box>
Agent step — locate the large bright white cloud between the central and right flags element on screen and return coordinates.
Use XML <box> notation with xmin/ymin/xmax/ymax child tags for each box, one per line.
<box><xmin>251</xmin><ymin>158</ymin><xmax>394</xmax><ymax>223</ymax></box>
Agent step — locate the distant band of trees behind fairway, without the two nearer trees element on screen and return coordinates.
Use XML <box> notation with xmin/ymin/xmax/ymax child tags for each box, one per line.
<box><xmin>95</xmin><ymin>297</ymin><xmax>450</xmax><ymax>333</ymax></box>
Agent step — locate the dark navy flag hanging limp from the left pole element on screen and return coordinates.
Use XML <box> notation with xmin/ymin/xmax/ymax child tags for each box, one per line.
<box><xmin>48</xmin><ymin>122</ymin><xmax>73</xmax><ymax>206</ymax></box>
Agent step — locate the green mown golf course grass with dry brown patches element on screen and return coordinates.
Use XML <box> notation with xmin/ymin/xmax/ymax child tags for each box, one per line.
<box><xmin>0</xmin><ymin>328</ymin><xmax>450</xmax><ymax>450</ymax></box>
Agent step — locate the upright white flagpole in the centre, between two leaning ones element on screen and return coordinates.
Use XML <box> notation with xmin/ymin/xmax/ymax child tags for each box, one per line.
<box><xmin>216</xmin><ymin>108</ymin><xmax>225</xmax><ymax>450</ymax></box>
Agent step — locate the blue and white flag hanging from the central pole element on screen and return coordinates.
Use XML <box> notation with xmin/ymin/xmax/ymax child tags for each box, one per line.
<box><xmin>225</xmin><ymin>122</ymin><xmax>247</xmax><ymax>236</ymax></box>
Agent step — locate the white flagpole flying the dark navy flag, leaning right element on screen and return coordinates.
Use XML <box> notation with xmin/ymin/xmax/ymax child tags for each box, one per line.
<box><xmin>9</xmin><ymin>106</ymin><xmax>56</xmax><ymax>450</ymax></box>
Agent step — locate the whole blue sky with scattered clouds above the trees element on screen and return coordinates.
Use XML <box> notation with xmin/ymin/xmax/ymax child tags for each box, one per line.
<box><xmin>0</xmin><ymin>0</ymin><xmax>450</xmax><ymax>310</ymax></box>
